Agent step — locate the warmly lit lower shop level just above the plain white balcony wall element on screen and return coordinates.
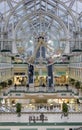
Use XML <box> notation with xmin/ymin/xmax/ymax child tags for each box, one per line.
<box><xmin>1</xmin><ymin>95</ymin><xmax>81</xmax><ymax>112</ymax></box>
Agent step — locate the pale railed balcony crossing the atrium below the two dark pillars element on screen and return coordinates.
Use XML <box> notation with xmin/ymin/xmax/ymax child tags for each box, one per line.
<box><xmin>1</xmin><ymin>86</ymin><xmax>78</xmax><ymax>98</ymax></box>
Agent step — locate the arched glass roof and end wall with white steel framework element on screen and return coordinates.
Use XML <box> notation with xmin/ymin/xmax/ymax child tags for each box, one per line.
<box><xmin>0</xmin><ymin>0</ymin><xmax>82</xmax><ymax>66</ymax></box>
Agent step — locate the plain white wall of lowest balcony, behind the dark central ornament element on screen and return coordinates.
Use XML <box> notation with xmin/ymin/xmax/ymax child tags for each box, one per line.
<box><xmin>0</xmin><ymin>112</ymin><xmax>82</xmax><ymax>123</ymax></box>
